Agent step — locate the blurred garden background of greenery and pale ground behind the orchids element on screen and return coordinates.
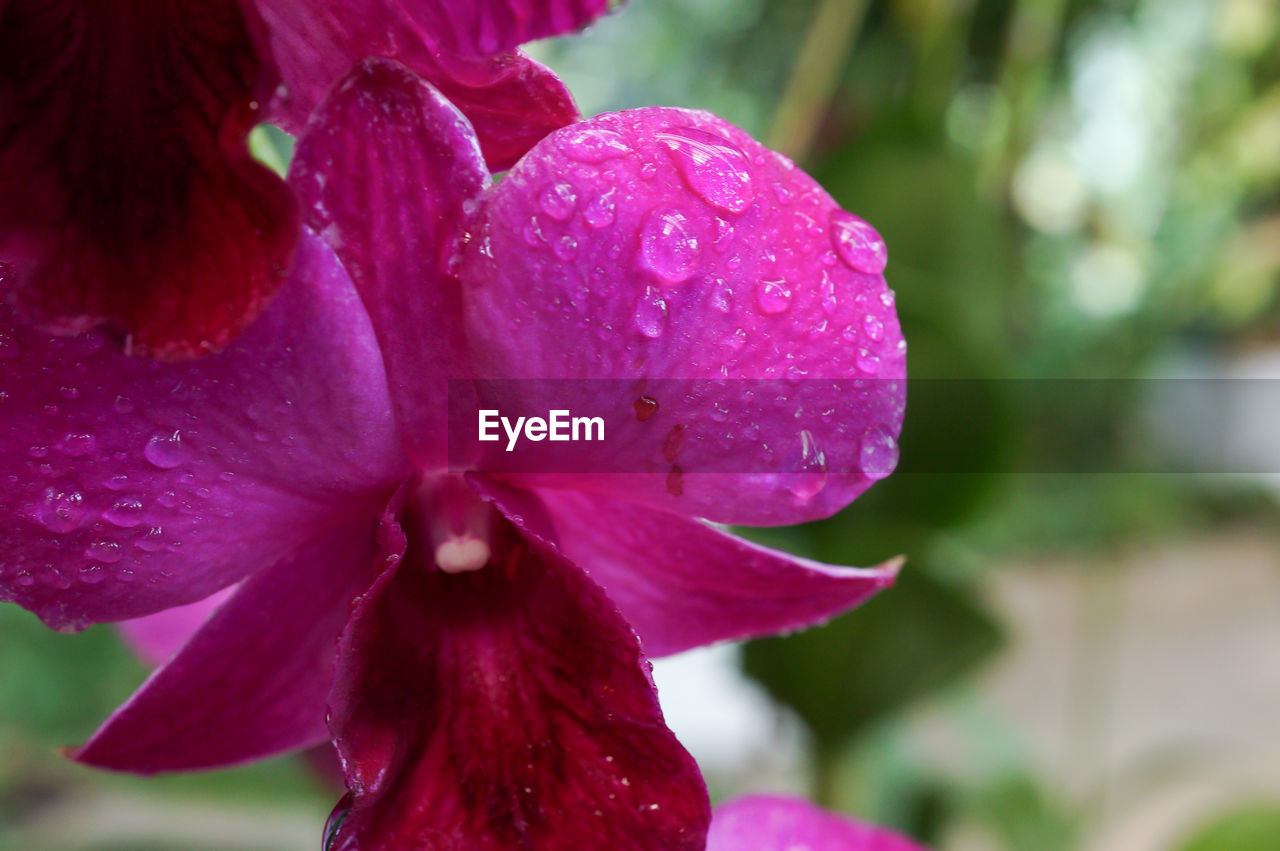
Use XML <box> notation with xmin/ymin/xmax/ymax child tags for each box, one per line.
<box><xmin>0</xmin><ymin>0</ymin><xmax>1280</xmax><ymax>851</ymax></box>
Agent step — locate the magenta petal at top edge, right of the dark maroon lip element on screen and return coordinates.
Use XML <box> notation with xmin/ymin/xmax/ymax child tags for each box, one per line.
<box><xmin>259</xmin><ymin>0</ymin><xmax>579</xmax><ymax>170</ymax></box>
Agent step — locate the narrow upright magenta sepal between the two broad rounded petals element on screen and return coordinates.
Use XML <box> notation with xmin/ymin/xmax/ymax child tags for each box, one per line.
<box><xmin>289</xmin><ymin>59</ymin><xmax>489</xmax><ymax>468</ymax></box>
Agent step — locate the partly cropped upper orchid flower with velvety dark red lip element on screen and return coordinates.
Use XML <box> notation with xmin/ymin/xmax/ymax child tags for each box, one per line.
<box><xmin>0</xmin><ymin>0</ymin><xmax>609</xmax><ymax>357</ymax></box>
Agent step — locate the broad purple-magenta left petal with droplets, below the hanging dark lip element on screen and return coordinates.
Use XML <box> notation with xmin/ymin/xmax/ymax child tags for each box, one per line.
<box><xmin>0</xmin><ymin>237</ymin><xmax>404</xmax><ymax>628</ymax></box>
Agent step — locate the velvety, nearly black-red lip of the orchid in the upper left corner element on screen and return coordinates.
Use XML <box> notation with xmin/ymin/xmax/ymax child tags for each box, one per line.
<box><xmin>0</xmin><ymin>0</ymin><xmax>298</xmax><ymax>357</ymax></box>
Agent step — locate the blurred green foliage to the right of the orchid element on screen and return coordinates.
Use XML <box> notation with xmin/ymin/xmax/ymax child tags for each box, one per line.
<box><xmin>548</xmin><ymin>0</ymin><xmax>1280</xmax><ymax>851</ymax></box>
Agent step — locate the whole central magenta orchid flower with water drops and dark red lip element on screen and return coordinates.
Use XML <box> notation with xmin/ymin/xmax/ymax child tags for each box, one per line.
<box><xmin>0</xmin><ymin>60</ymin><xmax>905</xmax><ymax>850</ymax></box>
